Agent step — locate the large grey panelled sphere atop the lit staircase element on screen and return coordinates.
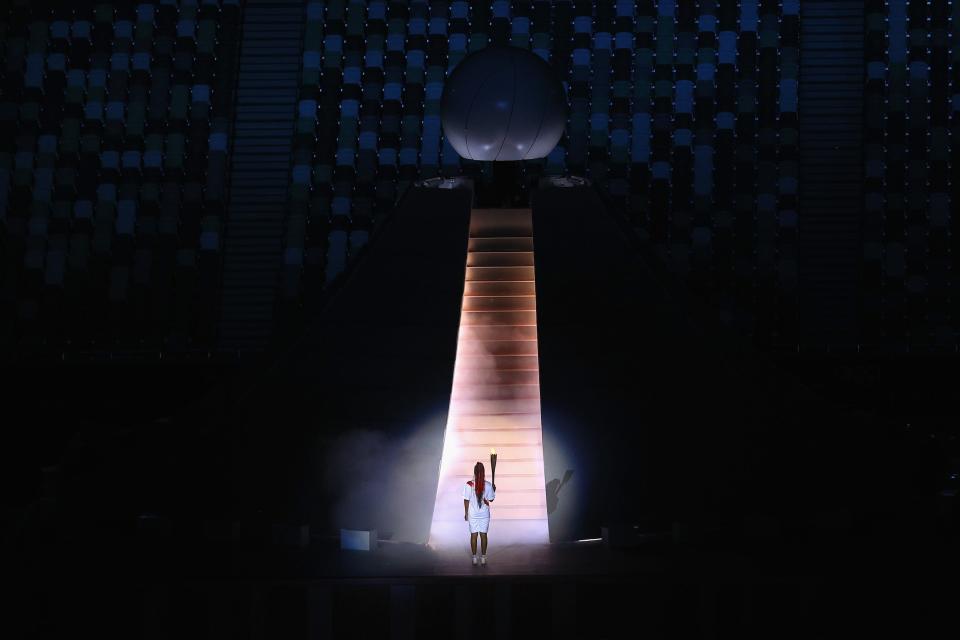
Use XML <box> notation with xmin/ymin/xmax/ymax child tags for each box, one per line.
<box><xmin>440</xmin><ymin>46</ymin><xmax>567</xmax><ymax>160</ymax></box>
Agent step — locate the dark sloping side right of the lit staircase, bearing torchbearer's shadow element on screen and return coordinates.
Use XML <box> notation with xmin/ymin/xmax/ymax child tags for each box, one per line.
<box><xmin>533</xmin><ymin>187</ymin><xmax>816</xmax><ymax>540</ymax></box>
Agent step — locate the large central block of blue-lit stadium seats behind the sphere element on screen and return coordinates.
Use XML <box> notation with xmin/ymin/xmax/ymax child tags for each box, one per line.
<box><xmin>287</xmin><ymin>0</ymin><xmax>799</xmax><ymax>338</ymax></box>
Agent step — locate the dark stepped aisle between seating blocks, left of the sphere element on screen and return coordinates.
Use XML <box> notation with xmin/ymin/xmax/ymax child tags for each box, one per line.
<box><xmin>219</xmin><ymin>0</ymin><xmax>304</xmax><ymax>353</ymax></box>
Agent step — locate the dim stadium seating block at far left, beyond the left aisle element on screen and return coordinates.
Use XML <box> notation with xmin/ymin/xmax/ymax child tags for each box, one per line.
<box><xmin>0</xmin><ymin>0</ymin><xmax>240</xmax><ymax>351</ymax></box>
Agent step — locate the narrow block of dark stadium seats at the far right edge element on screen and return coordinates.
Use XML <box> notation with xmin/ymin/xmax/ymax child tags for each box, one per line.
<box><xmin>861</xmin><ymin>0</ymin><xmax>960</xmax><ymax>349</ymax></box>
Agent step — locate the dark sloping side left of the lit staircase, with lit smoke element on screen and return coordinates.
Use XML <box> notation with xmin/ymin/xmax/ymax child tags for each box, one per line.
<box><xmin>238</xmin><ymin>189</ymin><xmax>471</xmax><ymax>541</ymax></box>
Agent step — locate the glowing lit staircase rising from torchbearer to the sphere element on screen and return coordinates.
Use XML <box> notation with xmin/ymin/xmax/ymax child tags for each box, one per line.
<box><xmin>428</xmin><ymin>209</ymin><xmax>550</xmax><ymax>548</ymax></box>
